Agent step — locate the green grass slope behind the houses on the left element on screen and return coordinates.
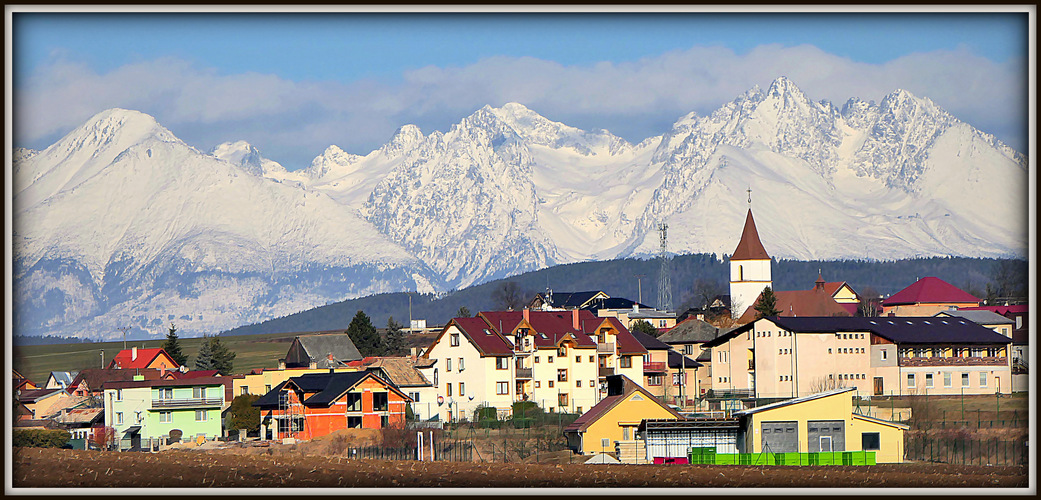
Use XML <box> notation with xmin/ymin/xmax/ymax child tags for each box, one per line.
<box><xmin>12</xmin><ymin>333</ymin><xmax>295</xmax><ymax>384</ymax></box>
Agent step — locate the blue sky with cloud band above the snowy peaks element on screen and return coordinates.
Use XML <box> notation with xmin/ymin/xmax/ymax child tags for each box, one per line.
<box><xmin>12</xmin><ymin>13</ymin><xmax>1027</xmax><ymax>170</ymax></box>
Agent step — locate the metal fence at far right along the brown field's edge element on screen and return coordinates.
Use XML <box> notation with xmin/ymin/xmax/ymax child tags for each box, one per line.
<box><xmin>904</xmin><ymin>436</ymin><xmax>1027</xmax><ymax>466</ymax></box>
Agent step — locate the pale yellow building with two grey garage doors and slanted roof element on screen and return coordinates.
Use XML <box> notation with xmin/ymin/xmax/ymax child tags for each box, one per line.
<box><xmin>735</xmin><ymin>388</ymin><xmax>908</xmax><ymax>464</ymax></box>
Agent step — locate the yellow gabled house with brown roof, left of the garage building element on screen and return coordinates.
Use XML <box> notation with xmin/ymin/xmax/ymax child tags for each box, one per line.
<box><xmin>564</xmin><ymin>375</ymin><xmax>683</xmax><ymax>454</ymax></box>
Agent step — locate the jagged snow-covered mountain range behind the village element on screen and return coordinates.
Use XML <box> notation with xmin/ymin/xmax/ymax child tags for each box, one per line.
<box><xmin>14</xmin><ymin>78</ymin><xmax>1027</xmax><ymax>339</ymax></box>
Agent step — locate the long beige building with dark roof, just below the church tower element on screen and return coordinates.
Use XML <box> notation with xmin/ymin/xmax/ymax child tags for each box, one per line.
<box><xmin>706</xmin><ymin>317</ymin><xmax>1012</xmax><ymax>398</ymax></box>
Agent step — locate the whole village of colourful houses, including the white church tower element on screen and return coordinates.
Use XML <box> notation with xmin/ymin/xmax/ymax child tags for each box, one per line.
<box><xmin>14</xmin><ymin>207</ymin><xmax>1029</xmax><ymax>464</ymax></box>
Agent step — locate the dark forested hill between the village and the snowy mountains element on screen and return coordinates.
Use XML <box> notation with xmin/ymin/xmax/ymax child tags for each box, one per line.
<box><xmin>224</xmin><ymin>254</ymin><xmax>1027</xmax><ymax>335</ymax></box>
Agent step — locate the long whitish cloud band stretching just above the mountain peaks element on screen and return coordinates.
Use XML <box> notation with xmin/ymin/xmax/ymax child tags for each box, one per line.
<box><xmin>15</xmin><ymin>45</ymin><xmax>1026</xmax><ymax>169</ymax></box>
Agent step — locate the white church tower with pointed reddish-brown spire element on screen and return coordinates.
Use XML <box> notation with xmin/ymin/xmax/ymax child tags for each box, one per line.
<box><xmin>730</xmin><ymin>208</ymin><xmax>773</xmax><ymax>318</ymax></box>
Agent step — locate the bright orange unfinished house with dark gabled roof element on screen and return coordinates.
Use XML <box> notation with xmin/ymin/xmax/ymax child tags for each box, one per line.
<box><xmin>253</xmin><ymin>372</ymin><xmax>411</xmax><ymax>441</ymax></box>
